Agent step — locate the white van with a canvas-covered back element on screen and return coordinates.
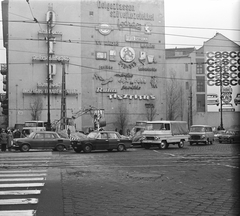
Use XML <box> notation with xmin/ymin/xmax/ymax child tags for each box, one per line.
<box><xmin>142</xmin><ymin>121</ymin><xmax>189</xmax><ymax>149</ymax></box>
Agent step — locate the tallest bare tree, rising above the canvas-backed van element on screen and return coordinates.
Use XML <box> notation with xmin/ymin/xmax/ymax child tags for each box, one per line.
<box><xmin>166</xmin><ymin>71</ymin><xmax>183</xmax><ymax>120</ymax></box>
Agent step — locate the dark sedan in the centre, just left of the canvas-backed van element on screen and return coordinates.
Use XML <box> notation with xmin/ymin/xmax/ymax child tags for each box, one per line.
<box><xmin>72</xmin><ymin>131</ymin><xmax>132</xmax><ymax>153</ymax></box>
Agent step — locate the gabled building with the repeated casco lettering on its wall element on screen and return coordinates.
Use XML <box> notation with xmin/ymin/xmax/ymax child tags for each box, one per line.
<box><xmin>166</xmin><ymin>33</ymin><xmax>240</xmax><ymax>128</ymax></box>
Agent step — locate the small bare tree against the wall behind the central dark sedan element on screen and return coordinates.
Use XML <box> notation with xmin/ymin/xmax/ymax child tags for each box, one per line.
<box><xmin>116</xmin><ymin>104</ymin><xmax>129</xmax><ymax>133</ymax></box>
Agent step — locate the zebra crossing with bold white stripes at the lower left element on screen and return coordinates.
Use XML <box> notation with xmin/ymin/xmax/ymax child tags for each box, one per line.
<box><xmin>0</xmin><ymin>155</ymin><xmax>51</xmax><ymax>216</ymax></box>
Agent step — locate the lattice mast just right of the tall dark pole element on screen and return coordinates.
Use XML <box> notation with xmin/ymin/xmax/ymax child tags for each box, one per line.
<box><xmin>61</xmin><ymin>61</ymin><xmax>66</xmax><ymax>129</ymax></box>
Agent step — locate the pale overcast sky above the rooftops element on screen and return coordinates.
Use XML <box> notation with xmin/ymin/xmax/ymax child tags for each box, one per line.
<box><xmin>0</xmin><ymin>0</ymin><xmax>240</xmax><ymax>89</ymax></box>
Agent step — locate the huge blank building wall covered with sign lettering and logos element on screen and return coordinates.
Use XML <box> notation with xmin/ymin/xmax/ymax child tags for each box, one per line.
<box><xmin>2</xmin><ymin>0</ymin><xmax>166</xmax><ymax>130</ymax></box>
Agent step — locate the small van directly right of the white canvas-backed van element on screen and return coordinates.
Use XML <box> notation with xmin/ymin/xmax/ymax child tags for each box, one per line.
<box><xmin>189</xmin><ymin>125</ymin><xmax>214</xmax><ymax>145</ymax></box>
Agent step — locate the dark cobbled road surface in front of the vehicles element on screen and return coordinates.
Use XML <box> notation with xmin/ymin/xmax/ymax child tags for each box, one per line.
<box><xmin>0</xmin><ymin>143</ymin><xmax>240</xmax><ymax>216</ymax></box>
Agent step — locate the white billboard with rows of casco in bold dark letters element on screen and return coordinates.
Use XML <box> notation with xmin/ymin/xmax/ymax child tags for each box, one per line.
<box><xmin>206</xmin><ymin>51</ymin><xmax>240</xmax><ymax>112</ymax></box>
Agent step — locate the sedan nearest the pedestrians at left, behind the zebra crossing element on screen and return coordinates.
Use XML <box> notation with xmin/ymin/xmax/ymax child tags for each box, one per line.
<box><xmin>11</xmin><ymin>131</ymin><xmax>71</xmax><ymax>152</ymax></box>
